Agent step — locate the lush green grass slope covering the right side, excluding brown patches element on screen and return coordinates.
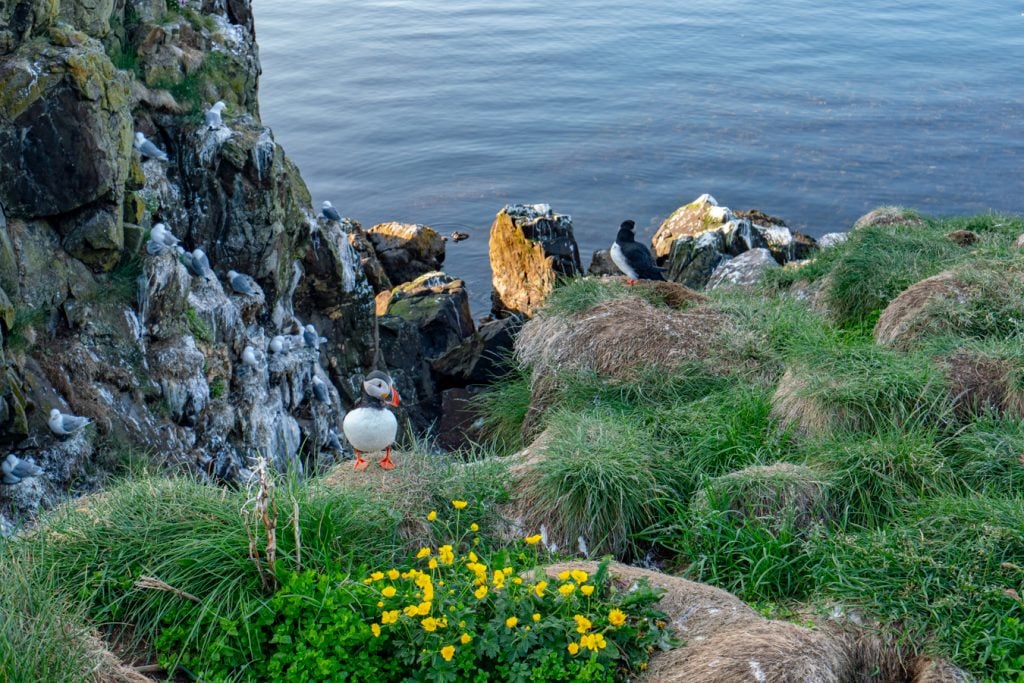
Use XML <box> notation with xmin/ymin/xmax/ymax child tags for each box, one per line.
<box><xmin>488</xmin><ymin>215</ymin><xmax>1024</xmax><ymax>680</ymax></box>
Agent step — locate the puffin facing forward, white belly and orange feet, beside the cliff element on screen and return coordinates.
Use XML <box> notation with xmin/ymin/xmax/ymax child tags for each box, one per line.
<box><xmin>341</xmin><ymin>370</ymin><xmax>398</xmax><ymax>472</ymax></box>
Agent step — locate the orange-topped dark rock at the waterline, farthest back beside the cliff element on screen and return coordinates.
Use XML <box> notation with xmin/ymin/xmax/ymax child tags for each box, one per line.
<box><xmin>367</xmin><ymin>222</ymin><xmax>444</xmax><ymax>284</ymax></box>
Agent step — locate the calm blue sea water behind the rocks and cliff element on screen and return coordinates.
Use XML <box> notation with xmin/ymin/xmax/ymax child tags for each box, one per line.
<box><xmin>255</xmin><ymin>0</ymin><xmax>1024</xmax><ymax>313</ymax></box>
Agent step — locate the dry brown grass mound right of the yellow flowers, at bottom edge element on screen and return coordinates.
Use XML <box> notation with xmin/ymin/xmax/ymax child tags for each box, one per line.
<box><xmin>545</xmin><ymin>562</ymin><xmax>969</xmax><ymax>683</ymax></box>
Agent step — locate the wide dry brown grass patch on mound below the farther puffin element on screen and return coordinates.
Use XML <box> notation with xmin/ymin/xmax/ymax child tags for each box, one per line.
<box><xmin>515</xmin><ymin>297</ymin><xmax>727</xmax><ymax>380</ymax></box>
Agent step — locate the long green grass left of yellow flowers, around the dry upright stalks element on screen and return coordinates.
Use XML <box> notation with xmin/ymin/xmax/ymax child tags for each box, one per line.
<box><xmin>3</xmin><ymin>478</ymin><xmax>400</xmax><ymax>667</ymax></box>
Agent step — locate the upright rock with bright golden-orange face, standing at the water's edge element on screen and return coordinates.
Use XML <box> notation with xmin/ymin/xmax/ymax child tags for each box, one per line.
<box><xmin>489</xmin><ymin>204</ymin><xmax>583</xmax><ymax>317</ymax></box>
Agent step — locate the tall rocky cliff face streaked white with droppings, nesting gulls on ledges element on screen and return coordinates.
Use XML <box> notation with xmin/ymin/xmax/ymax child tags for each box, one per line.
<box><xmin>0</xmin><ymin>0</ymin><xmax>375</xmax><ymax>525</ymax></box>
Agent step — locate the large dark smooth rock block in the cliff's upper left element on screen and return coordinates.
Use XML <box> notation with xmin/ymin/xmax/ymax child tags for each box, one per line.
<box><xmin>0</xmin><ymin>39</ymin><xmax>132</xmax><ymax>217</ymax></box>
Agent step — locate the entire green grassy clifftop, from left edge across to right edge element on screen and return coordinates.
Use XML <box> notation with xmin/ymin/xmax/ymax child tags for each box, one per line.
<box><xmin>0</xmin><ymin>210</ymin><xmax>1024</xmax><ymax>681</ymax></box>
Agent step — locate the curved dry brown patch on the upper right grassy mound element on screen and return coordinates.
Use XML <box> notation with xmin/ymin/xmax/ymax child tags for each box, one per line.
<box><xmin>874</xmin><ymin>270</ymin><xmax>970</xmax><ymax>350</ymax></box>
